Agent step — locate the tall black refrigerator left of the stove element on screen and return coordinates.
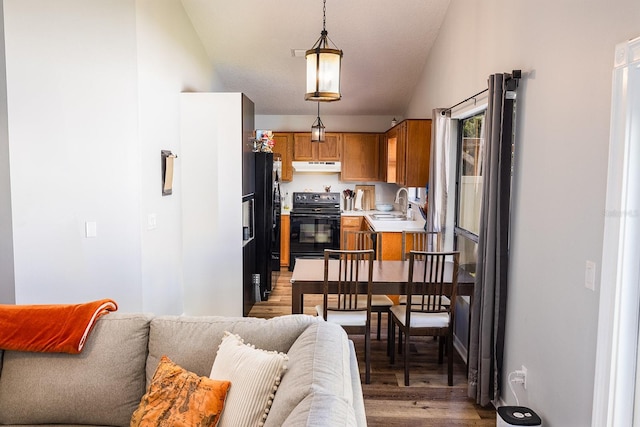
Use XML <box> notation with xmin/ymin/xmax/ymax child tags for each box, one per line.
<box><xmin>254</xmin><ymin>152</ymin><xmax>280</xmax><ymax>301</ymax></box>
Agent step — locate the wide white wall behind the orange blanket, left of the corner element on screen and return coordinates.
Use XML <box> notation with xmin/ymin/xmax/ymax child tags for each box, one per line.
<box><xmin>4</xmin><ymin>0</ymin><xmax>142</xmax><ymax>309</ymax></box>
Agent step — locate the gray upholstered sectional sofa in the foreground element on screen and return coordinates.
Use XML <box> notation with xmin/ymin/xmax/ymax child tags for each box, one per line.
<box><xmin>0</xmin><ymin>313</ymin><xmax>366</xmax><ymax>427</ymax></box>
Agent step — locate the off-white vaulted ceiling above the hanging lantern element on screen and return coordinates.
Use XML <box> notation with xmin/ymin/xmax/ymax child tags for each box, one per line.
<box><xmin>182</xmin><ymin>0</ymin><xmax>449</xmax><ymax>115</ymax></box>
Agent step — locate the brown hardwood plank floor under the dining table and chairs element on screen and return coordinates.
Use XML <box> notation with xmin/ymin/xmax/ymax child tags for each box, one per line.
<box><xmin>250</xmin><ymin>269</ymin><xmax>496</xmax><ymax>427</ymax></box>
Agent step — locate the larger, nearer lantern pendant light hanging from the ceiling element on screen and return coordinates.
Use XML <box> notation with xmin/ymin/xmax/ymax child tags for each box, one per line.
<box><xmin>304</xmin><ymin>0</ymin><xmax>342</xmax><ymax>102</ymax></box>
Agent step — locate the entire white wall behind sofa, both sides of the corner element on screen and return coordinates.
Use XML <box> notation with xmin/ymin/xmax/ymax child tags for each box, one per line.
<box><xmin>0</xmin><ymin>0</ymin><xmax>214</xmax><ymax>313</ymax></box>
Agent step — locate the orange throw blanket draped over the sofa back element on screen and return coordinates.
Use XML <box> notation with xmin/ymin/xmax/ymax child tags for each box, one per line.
<box><xmin>0</xmin><ymin>299</ymin><xmax>118</xmax><ymax>354</ymax></box>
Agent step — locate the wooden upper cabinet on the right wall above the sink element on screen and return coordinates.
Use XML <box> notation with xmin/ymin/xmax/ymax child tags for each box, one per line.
<box><xmin>385</xmin><ymin>119</ymin><xmax>431</xmax><ymax>187</ymax></box>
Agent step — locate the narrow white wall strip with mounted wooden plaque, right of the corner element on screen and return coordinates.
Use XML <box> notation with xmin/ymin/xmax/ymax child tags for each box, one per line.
<box><xmin>136</xmin><ymin>0</ymin><xmax>213</xmax><ymax>314</ymax></box>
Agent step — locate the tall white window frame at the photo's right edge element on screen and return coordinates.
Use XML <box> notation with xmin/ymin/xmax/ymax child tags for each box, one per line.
<box><xmin>591</xmin><ymin>38</ymin><xmax>640</xmax><ymax>427</ymax></box>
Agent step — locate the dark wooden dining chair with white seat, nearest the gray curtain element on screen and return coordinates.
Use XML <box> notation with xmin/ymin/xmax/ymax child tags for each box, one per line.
<box><xmin>390</xmin><ymin>251</ymin><xmax>460</xmax><ymax>386</ymax></box>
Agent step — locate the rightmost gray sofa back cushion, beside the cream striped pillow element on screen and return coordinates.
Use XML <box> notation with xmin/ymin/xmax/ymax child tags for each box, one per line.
<box><xmin>265</xmin><ymin>321</ymin><xmax>353</xmax><ymax>427</ymax></box>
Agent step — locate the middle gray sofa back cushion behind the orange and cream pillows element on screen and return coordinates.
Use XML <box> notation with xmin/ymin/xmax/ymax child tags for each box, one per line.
<box><xmin>146</xmin><ymin>314</ymin><xmax>318</xmax><ymax>384</ymax></box>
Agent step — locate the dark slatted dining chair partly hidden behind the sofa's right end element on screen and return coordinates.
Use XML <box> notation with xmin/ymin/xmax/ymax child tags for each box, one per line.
<box><xmin>316</xmin><ymin>249</ymin><xmax>373</xmax><ymax>384</ymax></box>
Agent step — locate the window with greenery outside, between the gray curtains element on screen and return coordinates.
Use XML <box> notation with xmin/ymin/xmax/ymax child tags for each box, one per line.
<box><xmin>455</xmin><ymin>111</ymin><xmax>485</xmax><ymax>273</ymax></box>
